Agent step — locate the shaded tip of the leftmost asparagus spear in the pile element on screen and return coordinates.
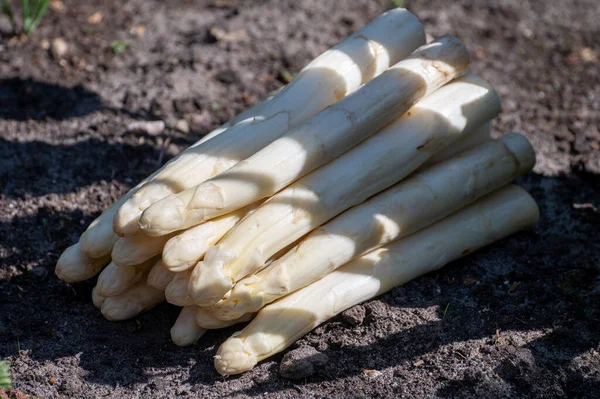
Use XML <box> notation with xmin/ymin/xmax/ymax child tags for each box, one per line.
<box><xmin>54</xmin><ymin>242</ymin><xmax>110</xmax><ymax>283</ymax></box>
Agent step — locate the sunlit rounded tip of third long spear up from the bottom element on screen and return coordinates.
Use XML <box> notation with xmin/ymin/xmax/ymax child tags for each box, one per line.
<box><xmin>188</xmin><ymin>246</ymin><xmax>236</xmax><ymax>306</ymax></box>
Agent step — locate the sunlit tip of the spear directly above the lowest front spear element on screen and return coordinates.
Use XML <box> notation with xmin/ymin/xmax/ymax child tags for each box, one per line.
<box><xmin>211</xmin><ymin>275</ymin><xmax>265</xmax><ymax>320</ymax></box>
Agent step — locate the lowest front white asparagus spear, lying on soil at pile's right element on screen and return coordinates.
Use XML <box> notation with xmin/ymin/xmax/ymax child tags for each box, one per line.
<box><xmin>215</xmin><ymin>186</ymin><xmax>539</xmax><ymax>375</ymax></box>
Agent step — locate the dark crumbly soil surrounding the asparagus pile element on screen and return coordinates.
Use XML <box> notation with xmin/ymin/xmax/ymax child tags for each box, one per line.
<box><xmin>0</xmin><ymin>0</ymin><xmax>600</xmax><ymax>398</ymax></box>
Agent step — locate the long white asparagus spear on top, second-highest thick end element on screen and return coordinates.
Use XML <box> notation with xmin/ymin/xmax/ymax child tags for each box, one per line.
<box><xmin>140</xmin><ymin>36</ymin><xmax>469</xmax><ymax>236</ymax></box>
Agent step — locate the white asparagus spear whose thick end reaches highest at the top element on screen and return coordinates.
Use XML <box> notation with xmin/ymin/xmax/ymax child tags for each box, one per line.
<box><xmin>114</xmin><ymin>9</ymin><xmax>425</xmax><ymax>235</ymax></box>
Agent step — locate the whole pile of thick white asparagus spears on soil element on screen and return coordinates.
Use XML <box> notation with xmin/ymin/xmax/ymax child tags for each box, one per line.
<box><xmin>56</xmin><ymin>9</ymin><xmax>538</xmax><ymax>375</ymax></box>
